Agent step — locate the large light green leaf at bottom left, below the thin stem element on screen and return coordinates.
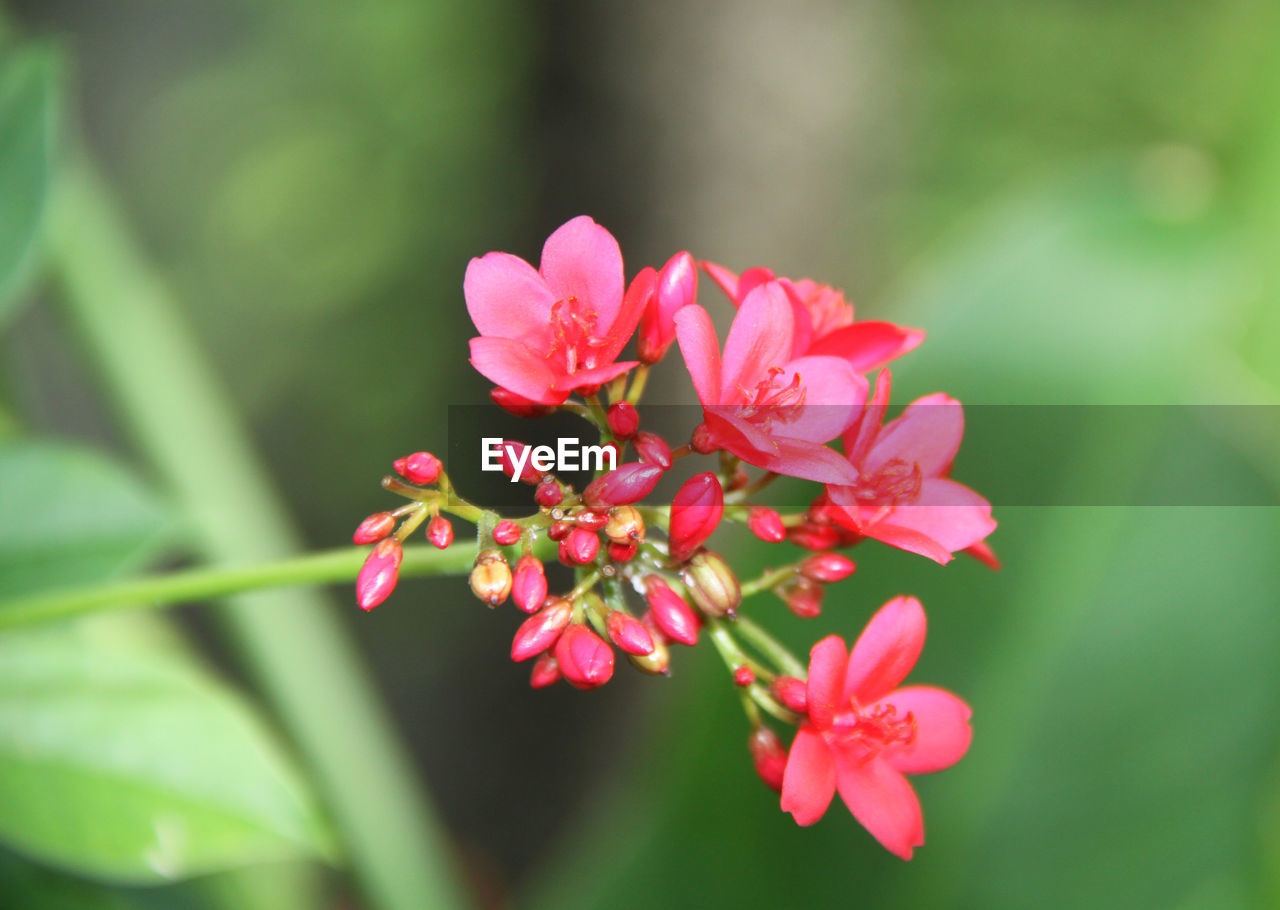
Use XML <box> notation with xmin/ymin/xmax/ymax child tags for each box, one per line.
<box><xmin>0</xmin><ymin>627</ymin><xmax>328</xmax><ymax>883</ymax></box>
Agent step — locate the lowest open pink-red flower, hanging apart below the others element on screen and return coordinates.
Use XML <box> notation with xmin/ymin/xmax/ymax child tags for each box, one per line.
<box><xmin>782</xmin><ymin>598</ymin><xmax>973</xmax><ymax>859</ymax></box>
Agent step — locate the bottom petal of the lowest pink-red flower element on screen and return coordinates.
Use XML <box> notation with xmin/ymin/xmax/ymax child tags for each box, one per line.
<box><xmin>836</xmin><ymin>754</ymin><xmax>924</xmax><ymax>860</ymax></box>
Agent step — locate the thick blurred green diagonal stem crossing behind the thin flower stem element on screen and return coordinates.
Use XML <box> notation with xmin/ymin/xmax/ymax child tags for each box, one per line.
<box><xmin>49</xmin><ymin>160</ymin><xmax>476</xmax><ymax>910</ymax></box>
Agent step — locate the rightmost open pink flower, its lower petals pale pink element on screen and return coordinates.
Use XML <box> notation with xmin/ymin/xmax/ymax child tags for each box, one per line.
<box><xmin>827</xmin><ymin>370</ymin><xmax>996</xmax><ymax>564</ymax></box>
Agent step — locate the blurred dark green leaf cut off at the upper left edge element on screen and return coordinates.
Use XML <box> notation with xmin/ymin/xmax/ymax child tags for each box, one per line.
<box><xmin>0</xmin><ymin>46</ymin><xmax>61</xmax><ymax>326</ymax></box>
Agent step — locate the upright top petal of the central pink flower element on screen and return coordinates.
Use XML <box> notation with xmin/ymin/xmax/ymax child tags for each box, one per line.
<box><xmin>721</xmin><ymin>282</ymin><xmax>795</xmax><ymax>401</ymax></box>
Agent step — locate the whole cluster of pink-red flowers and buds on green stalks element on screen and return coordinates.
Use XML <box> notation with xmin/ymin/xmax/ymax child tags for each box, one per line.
<box><xmin>355</xmin><ymin>216</ymin><xmax>997</xmax><ymax>859</ymax></box>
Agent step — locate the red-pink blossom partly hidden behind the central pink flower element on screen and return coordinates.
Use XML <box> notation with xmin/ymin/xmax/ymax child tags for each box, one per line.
<box><xmin>701</xmin><ymin>261</ymin><xmax>924</xmax><ymax>372</ymax></box>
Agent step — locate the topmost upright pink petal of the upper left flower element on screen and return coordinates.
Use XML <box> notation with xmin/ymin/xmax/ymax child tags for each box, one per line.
<box><xmin>541</xmin><ymin>215</ymin><xmax>622</xmax><ymax>334</ymax></box>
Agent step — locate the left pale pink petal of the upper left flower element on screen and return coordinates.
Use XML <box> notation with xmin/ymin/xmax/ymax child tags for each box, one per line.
<box><xmin>462</xmin><ymin>252</ymin><xmax>556</xmax><ymax>349</ymax></box>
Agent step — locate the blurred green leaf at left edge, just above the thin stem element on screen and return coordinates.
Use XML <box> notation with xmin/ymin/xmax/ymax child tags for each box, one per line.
<box><xmin>0</xmin><ymin>440</ymin><xmax>173</xmax><ymax>599</ymax></box>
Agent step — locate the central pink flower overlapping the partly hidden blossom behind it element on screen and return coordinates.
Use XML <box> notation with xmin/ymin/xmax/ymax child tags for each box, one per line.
<box><xmin>675</xmin><ymin>282</ymin><xmax>867</xmax><ymax>484</ymax></box>
